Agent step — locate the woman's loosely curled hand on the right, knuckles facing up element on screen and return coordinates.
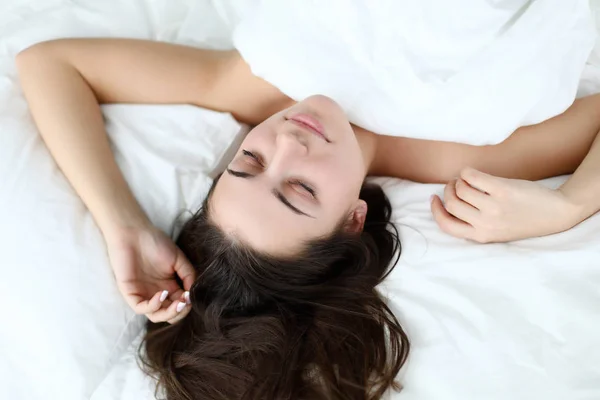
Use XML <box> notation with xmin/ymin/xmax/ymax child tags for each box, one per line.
<box><xmin>431</xmin><ymin>168</ymin><xmax>580</xmax><ymax>243</ymax></box>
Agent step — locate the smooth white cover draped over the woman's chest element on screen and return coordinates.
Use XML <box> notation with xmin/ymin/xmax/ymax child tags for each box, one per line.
<box><xmin>234</xmin><ymin>0</ymin><xmax>595</xmax><ymax>145</ymax></box>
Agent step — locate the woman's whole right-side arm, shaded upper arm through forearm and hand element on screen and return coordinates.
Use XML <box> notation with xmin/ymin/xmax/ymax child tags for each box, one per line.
<box><xmin>366</xmin><ymin>94</ymin><xmax>600</xmax><ymax>242</ymax></box>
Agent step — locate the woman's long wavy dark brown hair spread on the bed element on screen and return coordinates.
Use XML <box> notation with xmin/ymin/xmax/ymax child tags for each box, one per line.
<box><xmin>140</xmin><ymin>181</ymin><xmax>409</xmax><ymax>400</ymax></box>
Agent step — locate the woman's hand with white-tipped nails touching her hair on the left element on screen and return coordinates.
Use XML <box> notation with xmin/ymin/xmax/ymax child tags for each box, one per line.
<box><xmin>105</xmin><ymin>226</ymin><xmax>195</xmax><ymax>324</ymax></box>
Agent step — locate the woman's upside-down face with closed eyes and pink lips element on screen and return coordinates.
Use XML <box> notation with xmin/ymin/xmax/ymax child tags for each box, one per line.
<box><xmin>210</xmin><ymin>96</ymin><xmax>366</xmax><ymax>255</ymax></box>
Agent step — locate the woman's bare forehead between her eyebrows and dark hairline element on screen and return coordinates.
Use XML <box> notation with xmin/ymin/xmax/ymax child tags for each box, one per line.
<box><xmin>209</xmin><ymin>173</ymin><xmax>334</xmax><ymax>255</ymax></box>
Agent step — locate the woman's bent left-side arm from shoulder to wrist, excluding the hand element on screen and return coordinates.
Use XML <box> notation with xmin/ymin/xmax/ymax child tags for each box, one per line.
<box><xmin>17</xmin><ymin>39</ymin><xmax>282</xmax><ymax>235</ymax></box>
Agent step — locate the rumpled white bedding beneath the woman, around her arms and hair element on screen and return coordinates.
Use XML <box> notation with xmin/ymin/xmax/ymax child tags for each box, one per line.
<box><xmin>0</xmin><ymin>0</ymin><xmax>600</xmax><ymax>400</ymax></box>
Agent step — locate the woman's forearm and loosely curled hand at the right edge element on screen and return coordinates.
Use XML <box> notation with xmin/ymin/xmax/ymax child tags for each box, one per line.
<box><xmin>431</xmin><ymin>130</ymin><xmax>600</xmax><ymax>243</ymax></box>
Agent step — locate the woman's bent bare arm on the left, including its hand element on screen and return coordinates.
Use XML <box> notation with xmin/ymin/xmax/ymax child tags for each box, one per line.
<box><xmin>17</xmin><ymin>39</ymin><xmax>287</xmax><ymax>323</ymax></box>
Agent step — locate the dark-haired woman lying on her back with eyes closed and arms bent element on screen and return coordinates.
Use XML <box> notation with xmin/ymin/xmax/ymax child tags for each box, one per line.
<box><xmin>17</xmin><ymin>39</ymin><xmax>600</xmax><ymax>399</ymax></box>
